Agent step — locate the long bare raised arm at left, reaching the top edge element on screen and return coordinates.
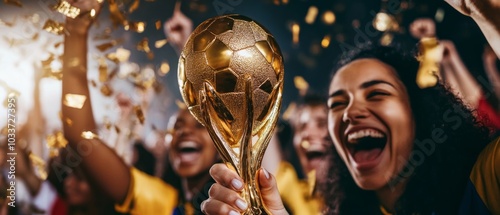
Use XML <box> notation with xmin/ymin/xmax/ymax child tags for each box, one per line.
<box><xmin>62</xmin><ymin>0</ymin><xmax>131</xmax><ymax>203</ymax></box>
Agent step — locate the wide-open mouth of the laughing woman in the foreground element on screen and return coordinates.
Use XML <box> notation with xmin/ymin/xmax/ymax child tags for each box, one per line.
<box><xmin>346</xmin><ymin>128</ymin><xmax>387</xmax><ymax>170</ymax></box>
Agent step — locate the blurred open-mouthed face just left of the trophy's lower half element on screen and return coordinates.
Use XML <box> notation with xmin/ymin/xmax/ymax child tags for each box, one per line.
<box><xmin>169</xmin><ymin>109</ymin><xmax>218</xmax><ymax>178</ymax></box>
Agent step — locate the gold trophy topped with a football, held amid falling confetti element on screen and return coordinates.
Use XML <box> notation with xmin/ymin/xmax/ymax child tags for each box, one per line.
<box><xmin>178</xmin><ymin>15</ymin><xmax>284</xmax><ymax>214</ymax></box>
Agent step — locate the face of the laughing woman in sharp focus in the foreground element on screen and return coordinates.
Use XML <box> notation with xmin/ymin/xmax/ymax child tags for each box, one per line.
<box><xmin>328</xmin><ymin>58</ymin><xmax>415</xmax><ymax>190</ymax></box>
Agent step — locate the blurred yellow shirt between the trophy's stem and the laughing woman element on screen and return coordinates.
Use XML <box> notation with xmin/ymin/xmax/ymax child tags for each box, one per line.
<box><xmin>276</xmin><ymin>162</ymin><xmax>322</xmax><ymax>215</ymax></box>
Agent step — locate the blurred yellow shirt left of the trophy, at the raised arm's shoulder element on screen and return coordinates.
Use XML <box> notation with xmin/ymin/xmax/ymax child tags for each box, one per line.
<box><xmin>115</xmin><ymin>168</ymin><xmax>179</xmax><ymax>215</ymax></box>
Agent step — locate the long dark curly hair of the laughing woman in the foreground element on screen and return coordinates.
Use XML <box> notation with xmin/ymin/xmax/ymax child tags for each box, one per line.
<box><xmin>320</xmin><ymin>44</ymin><xmax>489</xmax><ymax>215</ymax></box>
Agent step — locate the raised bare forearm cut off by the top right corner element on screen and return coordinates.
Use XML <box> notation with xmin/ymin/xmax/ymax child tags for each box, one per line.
<box><xmin>445</xmin><ymin>0</ymin><xmax>500</xmax><ymax>58</ymax></box>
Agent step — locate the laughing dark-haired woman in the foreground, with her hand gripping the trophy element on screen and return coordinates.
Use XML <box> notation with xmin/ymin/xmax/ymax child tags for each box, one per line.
<box><xmin>202</xmin><ymin>43</ymin><xmax>500</xmax><ymax>214</ymax></box>
